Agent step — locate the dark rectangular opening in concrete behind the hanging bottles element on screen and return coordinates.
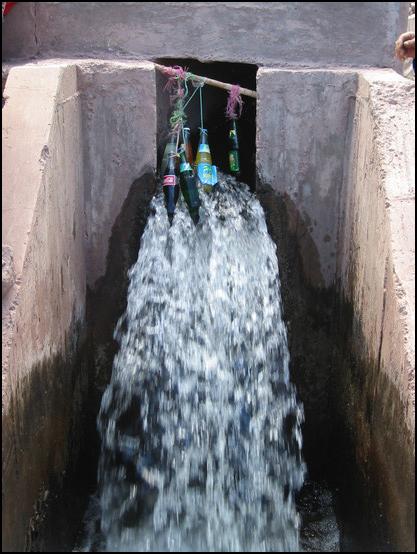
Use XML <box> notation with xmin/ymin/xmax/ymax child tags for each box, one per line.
<box><xmin>155</xmin><ymin>58</ymin><xmax>258</xmax><ymax>190</ymax></box>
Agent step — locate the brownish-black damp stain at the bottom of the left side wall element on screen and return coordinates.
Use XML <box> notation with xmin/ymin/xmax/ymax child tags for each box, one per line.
<box><xmin>2</xmin><ymin>310</ymin><xmax>88</xmax><ymax>552</ymax></box>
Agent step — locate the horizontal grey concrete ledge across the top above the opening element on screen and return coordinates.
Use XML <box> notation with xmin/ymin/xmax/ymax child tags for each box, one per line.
<box><xmin>3</xmin><ymin>2</ymin><xmax>408</xmax><ymax>69</ymax></box>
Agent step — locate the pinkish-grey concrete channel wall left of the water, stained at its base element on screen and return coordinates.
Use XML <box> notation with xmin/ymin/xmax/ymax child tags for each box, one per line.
<box><xmin>2</xmin><ymin>62</ymin><xmax>156</xmax><ymax>551</ymax></box>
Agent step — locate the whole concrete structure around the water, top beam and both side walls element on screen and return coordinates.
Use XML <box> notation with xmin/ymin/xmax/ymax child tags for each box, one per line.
<box><xmin>2</xmin><ymin>2</ymin><xmax>414</xmax><ymax>551</ymax></box>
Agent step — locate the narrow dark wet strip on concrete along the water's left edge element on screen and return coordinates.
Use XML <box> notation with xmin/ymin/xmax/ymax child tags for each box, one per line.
<box><xmin>86</xmin><ymin>170</ymin><xmax>157</xmax><ymax>480</ymax></box>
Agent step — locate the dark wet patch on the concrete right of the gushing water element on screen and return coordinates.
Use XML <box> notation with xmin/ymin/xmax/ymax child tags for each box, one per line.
<box><xmin>257</xmin><ymin>183</ymin><xmax>415</xmax><ymax>552</ymax></box>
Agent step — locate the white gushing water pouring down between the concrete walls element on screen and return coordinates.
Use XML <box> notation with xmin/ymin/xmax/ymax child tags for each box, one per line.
<box><xmin>87</xmin><ymin>171</ymin><xmax>304</xmax><ymax>552</ymax></box>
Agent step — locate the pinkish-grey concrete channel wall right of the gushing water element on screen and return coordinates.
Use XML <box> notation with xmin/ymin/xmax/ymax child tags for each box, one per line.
<box><xmin>256</xmin><ymin>64</ymin><xmax>415</xmax><ymax>551</ymax></box>
